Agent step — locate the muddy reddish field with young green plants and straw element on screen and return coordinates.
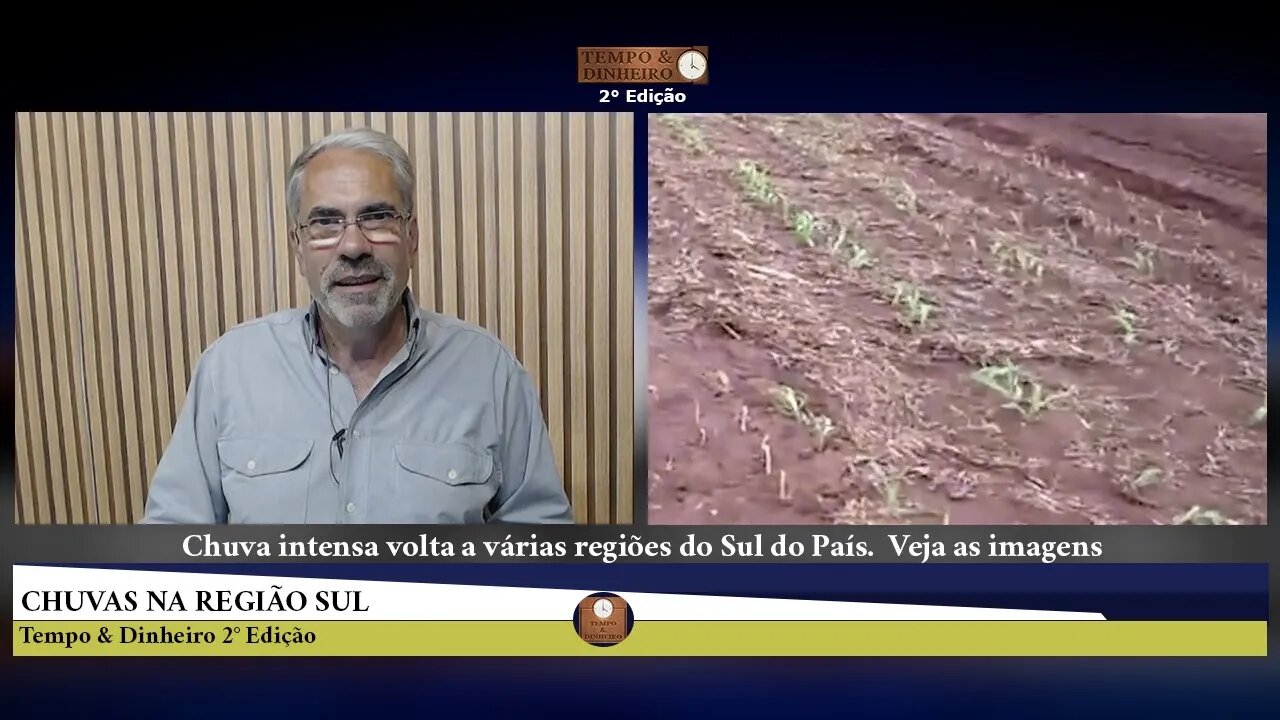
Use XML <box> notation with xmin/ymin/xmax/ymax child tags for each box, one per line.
<box><xmin>648</xmin><ymin>114</ymin><xmax>1267</xmax><ymax>524</ymax></box>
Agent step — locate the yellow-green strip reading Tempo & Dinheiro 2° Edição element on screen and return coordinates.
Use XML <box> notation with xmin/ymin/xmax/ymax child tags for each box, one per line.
<box><xmin>13</xmin><ymin>620</ymin><xmax>1267</xmax><ymax>656</ymax></box>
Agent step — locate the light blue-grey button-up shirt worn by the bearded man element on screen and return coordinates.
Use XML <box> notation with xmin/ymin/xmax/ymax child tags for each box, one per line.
<box><xmin>142</xmin><ymin>291</ymin><xmax>573</xmax><ymax>524</ymax></box>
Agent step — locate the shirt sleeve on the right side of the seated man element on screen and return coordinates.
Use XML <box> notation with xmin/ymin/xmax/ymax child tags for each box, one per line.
<box><xmin>489</xmin><ymin>361</ymin><xmax>573</xmax><ymax>524</ymax></box>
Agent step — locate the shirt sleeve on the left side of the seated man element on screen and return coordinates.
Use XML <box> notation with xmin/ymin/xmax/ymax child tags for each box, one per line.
<box><xmin>140</xmin><ymin>354</ymin><xmax>227</xmax><ymax>524</ymax></box>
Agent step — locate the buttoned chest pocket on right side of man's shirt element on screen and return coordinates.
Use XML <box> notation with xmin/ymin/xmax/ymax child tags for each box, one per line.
<box><xmin>393</xmin><ymin>441</ymin><xmax>497</xmax><ymax>524</ymax></box>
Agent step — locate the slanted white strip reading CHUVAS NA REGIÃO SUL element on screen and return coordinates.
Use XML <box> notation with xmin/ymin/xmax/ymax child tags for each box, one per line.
<box><xmin>13</xmin><ymin>565</ymin><xmax>1105</xmax><ymax>621</ymax></box>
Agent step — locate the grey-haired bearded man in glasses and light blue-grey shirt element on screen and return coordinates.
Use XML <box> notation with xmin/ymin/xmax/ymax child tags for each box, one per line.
<box><xmin>142</xmin><ymin>129</ymin><xmax>572</xmax><ymax>523</ymax></box>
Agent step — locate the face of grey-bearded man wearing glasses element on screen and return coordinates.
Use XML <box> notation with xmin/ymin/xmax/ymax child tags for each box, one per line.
<box><xmin>294</xmin><ymin>149</ymin><xmax>417</xmax><ymax>329</ymax></box>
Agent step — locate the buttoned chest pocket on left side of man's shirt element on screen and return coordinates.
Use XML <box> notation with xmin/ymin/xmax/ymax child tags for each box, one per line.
<box><xmin>218</xmin><ymin>437</ymin><xmax>315</xmax><ymax>523</ymax></box>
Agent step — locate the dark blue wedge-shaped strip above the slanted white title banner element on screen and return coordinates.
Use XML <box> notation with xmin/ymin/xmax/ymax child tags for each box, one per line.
<box><xmin>40</xmin><ymin>562</ymin><xmax>1268</xmax><ymax>620</ymax></box>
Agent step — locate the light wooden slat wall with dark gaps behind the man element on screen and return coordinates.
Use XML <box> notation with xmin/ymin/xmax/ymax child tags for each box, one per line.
<box><xmin>15</xmin><ymin>113</ymin><xmax>635</xmax><ymax>523</ymax></box>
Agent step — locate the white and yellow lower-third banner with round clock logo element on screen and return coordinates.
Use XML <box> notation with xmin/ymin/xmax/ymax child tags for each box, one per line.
<box><xmin>13</xmin><ymin>565</ymin><xmax>1266</xmax><ymax>656</ymax></box>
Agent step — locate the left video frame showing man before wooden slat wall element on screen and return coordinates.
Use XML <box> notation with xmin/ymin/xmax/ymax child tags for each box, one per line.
<box><xmin>14</xmin><ymin>111</ymin><xmax>644</xmax><ymax>524</ymax></box>
